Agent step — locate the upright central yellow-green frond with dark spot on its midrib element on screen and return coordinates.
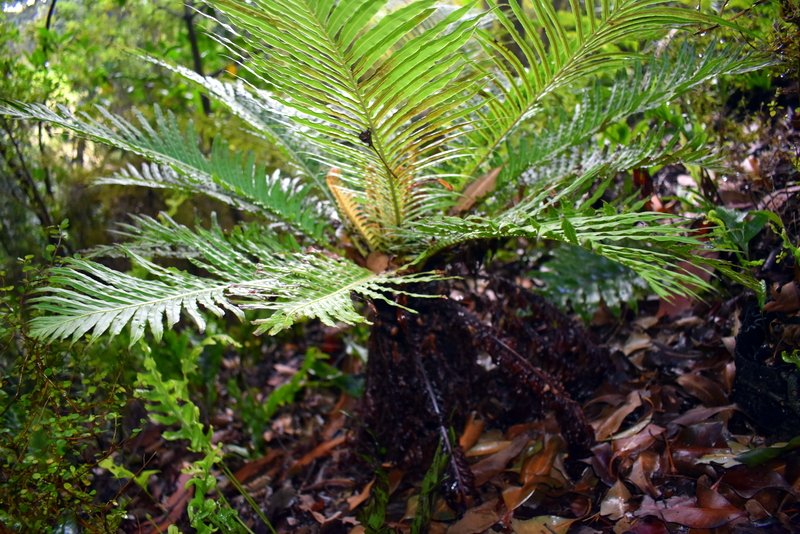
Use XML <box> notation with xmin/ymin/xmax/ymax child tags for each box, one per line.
<box><xmin>203</xmin><ymin>0</ymin><xmax>484</xmax><ymax>243</ymax></box>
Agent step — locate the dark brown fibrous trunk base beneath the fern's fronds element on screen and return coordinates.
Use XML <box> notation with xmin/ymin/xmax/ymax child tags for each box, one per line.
<box><xmin>361</xmin><ymin>280</ymin><xmax>610</xmax><ymax>480</ymax></box>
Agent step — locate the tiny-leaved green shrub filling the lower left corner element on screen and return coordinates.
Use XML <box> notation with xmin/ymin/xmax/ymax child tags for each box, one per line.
<box><xmin>0</xmin><ymin>258</ymin><xmax>130</xmax><ymax>532</ymax></box>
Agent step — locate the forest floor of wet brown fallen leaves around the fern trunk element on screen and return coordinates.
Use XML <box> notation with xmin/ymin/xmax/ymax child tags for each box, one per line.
<box><xmin>115</xmin><ymin>93</ymin><xmax>800</xmax><ymax>534</ymax></box>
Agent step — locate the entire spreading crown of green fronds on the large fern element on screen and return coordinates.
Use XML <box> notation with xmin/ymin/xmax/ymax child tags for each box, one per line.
<box><xmin>0</xmin><ymin>0</ymin><xmax>764</xmax><ymax>342</ymax></box>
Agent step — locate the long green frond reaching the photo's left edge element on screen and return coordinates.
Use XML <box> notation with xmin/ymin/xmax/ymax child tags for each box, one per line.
<box><xmin>0</xmin><ymin>103</ymin><xmax>322</xmax><ymax>238</ymax></box>
